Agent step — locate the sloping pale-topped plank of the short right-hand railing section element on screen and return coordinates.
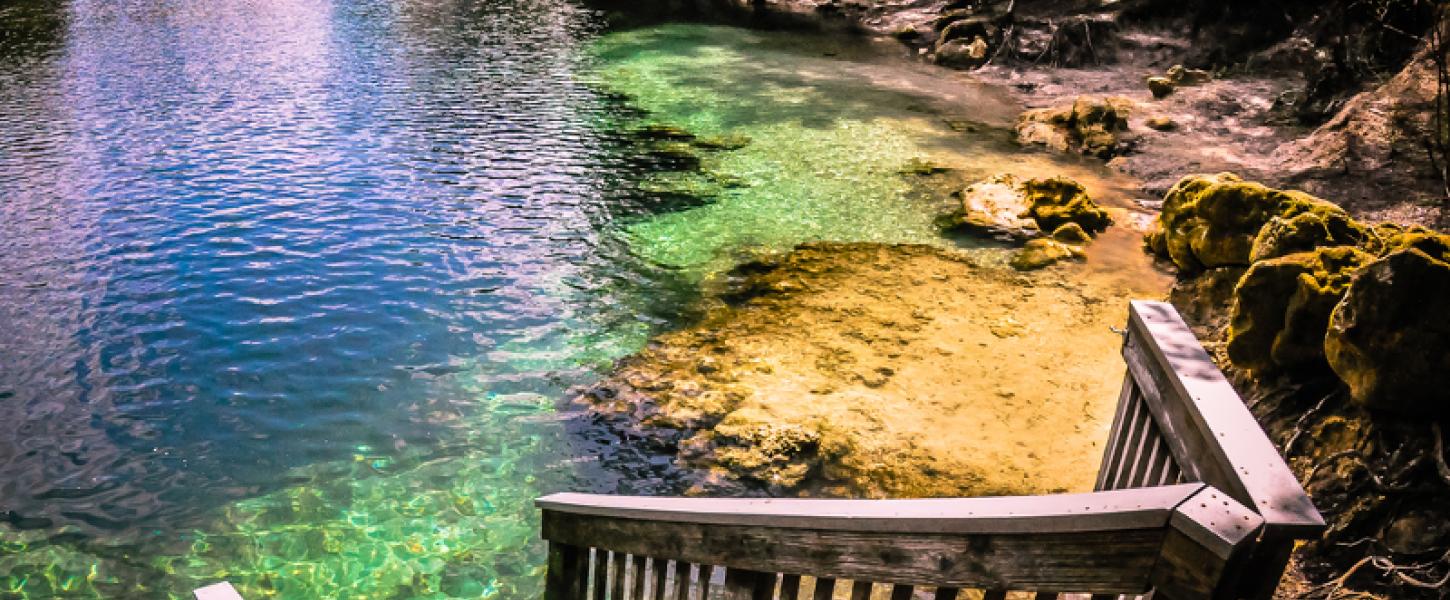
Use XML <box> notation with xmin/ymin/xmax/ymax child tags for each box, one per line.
<box><xmin>1124</xmin><ymin>301</ymin><xmax>1324</xmax><ymax>535</ymax></box>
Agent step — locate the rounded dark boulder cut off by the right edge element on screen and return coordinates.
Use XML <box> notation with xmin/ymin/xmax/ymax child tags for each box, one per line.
<box><xmin>1324</xmin><ymin>246</ymin><xmax>1450</xmax><ymax>414</ymax></box>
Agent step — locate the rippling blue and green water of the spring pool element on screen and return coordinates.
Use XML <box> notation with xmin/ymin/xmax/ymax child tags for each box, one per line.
<box><xmin>0</xmin><ymin>0</ymin><xmax>1154</xmax><ymax>599</ymax></box>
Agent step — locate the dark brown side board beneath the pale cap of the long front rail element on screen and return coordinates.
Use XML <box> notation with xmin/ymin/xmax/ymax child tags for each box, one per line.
<box><xmin>544</xmin><ymin>507</ymin><xmax>1177</xmax><ymax>593</ymax></box>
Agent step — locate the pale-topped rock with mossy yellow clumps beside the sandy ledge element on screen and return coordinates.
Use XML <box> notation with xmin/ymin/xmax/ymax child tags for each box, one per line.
<box><xmin>951</xmin><ymin>174</ymin><xmax>1112</xmax><ymax>271</ymax></box>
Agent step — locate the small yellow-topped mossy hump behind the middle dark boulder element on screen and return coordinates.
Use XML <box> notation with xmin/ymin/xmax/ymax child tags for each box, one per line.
<box><xmin>1248</xmin><ymin>203</ymin><xmax>1378</xmax><ymax>262</ymax></box>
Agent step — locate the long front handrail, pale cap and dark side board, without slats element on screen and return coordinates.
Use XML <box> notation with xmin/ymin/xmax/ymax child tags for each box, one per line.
<box><xmin>538</xmin><ymin>484</ymin><xmax>1263</xmax><ymax>599</ymax></box>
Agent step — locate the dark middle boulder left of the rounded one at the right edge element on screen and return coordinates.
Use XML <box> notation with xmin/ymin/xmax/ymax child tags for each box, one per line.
<box><xmin>1227</xmin><ymin>246</ymin><xmax>1375</xmax><ymax>374</ymax></box>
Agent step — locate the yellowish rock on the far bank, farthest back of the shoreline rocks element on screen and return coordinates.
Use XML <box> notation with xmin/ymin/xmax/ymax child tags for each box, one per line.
<box><xmin>1016</xmin><ymin>96</ymin><xmax>1132</xmax><ymax>159</ymax></box>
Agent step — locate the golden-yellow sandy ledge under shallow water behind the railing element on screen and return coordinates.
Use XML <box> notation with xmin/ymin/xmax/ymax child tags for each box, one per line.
<box><xmin>574</xmin><ymin>232</ymin><xmax>1166</xmax><ymax>497</ymax></box>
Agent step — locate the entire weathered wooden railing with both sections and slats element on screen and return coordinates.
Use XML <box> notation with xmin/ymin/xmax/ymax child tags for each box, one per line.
<box><xmin>538</xmin><ymin>301</ymin><xmax>1324</xmax><ymax>600</ymax></box>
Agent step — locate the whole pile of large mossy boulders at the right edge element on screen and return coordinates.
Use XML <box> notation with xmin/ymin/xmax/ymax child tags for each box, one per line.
<box><xmin>1146</xmin><ymin>174</ymin><xmax>1450</xmax><ymax>413</ymax></box>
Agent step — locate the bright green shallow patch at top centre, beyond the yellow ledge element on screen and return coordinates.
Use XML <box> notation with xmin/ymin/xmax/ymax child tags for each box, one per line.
<box><xmin>593</xmin><ymin>25</ymin><xmax>986</xmax><ymax>274</ymax></box>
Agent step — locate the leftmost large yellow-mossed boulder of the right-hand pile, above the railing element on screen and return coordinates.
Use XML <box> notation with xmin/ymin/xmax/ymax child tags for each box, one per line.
<box><xmin>1147</xmin><ymin>172</ymin><xmax>1343</xmax><ymax>272</ymax></box>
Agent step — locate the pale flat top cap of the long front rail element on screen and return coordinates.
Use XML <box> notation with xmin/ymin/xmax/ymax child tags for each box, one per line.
<box><xmin>535</xmin><ymin>486</ymin><xmax>1198</xmax><ymax>536</ymax></box>
